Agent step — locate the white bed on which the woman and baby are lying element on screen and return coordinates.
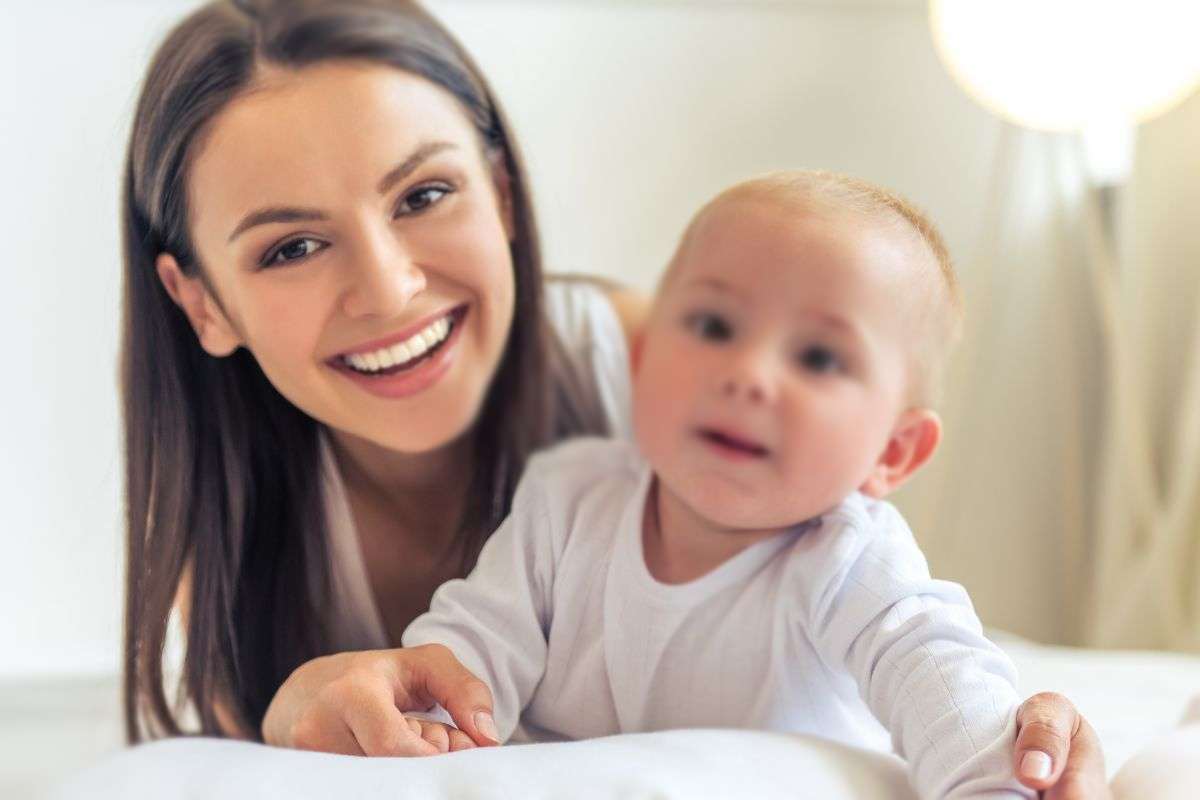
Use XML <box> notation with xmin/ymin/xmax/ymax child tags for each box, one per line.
<box><xmin>11</xmin><ymin>633</ymin><xmax>1200</xmax><ymax>800</ymax></box>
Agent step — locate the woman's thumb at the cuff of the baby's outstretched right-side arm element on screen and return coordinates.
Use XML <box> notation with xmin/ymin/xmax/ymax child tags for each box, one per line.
<box><xmin>1013</xmin><ymin>692</ymin><xmax>1082</xmax><ymax>789</ymax></box>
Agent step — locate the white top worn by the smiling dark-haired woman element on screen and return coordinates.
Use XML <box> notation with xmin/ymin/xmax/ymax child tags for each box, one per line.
<box><xmin>320</xmin><ymin>278</ymin><xmax>632</xmax><ymax>652</ymax></box>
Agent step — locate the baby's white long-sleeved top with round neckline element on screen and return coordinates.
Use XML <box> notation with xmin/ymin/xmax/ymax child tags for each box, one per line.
<box><xmin>403</xmin><ymin>439</ymin><xmax>1033</xmax><ymax>798</ymax></box>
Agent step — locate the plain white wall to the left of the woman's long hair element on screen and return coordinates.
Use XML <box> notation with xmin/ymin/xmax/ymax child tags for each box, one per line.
<box><xmin>0</xmin><ymin>0</ymin><xmax>196</xmax><ymax>675</ymax></box>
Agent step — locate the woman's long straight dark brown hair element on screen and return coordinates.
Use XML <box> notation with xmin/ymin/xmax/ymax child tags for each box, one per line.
<box><xmin>121</xmin><ymin>0</ymin><xmax>604</xmax><ymax>742</ymax></box>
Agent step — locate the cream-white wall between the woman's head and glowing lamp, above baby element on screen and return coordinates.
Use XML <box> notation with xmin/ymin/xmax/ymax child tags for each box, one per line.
<box><xmin>431</xmin><ymin>0</ymin><xmax>995</xmax><ymax>293</ymax></box>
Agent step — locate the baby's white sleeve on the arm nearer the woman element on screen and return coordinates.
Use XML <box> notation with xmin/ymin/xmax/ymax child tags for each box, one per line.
<box><xmin>402</xmin><ymin>463</ymin><xmax>556</xmax><ymax>741</ymax></box>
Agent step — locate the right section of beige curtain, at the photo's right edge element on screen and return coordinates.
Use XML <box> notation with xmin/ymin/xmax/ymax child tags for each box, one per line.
<box><xmin>1084</xmin><ymin>90</ymin><xmax>1200</xmax><ymax>651</ymax></box>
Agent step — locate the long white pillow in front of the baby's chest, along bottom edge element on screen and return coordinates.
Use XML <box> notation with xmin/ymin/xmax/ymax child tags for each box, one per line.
<box><xmin>44</xmin><ymin>730</ymin><xmax>916</xmax><ymax>800</ymax></box>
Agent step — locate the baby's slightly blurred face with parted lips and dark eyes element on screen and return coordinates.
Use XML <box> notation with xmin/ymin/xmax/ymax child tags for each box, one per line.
<box><xmin>634</xmin><ymin>198</ymin><xmax>922</xmax><ymax>530</ymax></box>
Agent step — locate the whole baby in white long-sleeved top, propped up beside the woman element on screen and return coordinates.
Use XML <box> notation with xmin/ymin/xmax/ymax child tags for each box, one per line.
<box><xmin>403</xmin><ymin>173</ymin><xmax>1032</xmax><ymax>798</ymax></box>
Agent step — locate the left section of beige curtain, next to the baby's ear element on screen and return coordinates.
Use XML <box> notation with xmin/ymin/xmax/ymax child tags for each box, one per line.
<box><xmin>898</xmin><ymin>121</ymin><xmax>1103</xmax><ymax>643</ymax></box>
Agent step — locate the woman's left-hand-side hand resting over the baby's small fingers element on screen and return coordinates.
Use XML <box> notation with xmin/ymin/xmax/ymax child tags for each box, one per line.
<box><xmin>263</xmin><ymin>644</ymin><xmax>498</xmax><ymax>756</ymax></box>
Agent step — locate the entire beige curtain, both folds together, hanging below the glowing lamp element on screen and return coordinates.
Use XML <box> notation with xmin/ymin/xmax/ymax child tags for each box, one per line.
<box><xmin>898</xmin><ymin>89</ymin><xmax>1200</xmax><ymax>650</ymax></box>
